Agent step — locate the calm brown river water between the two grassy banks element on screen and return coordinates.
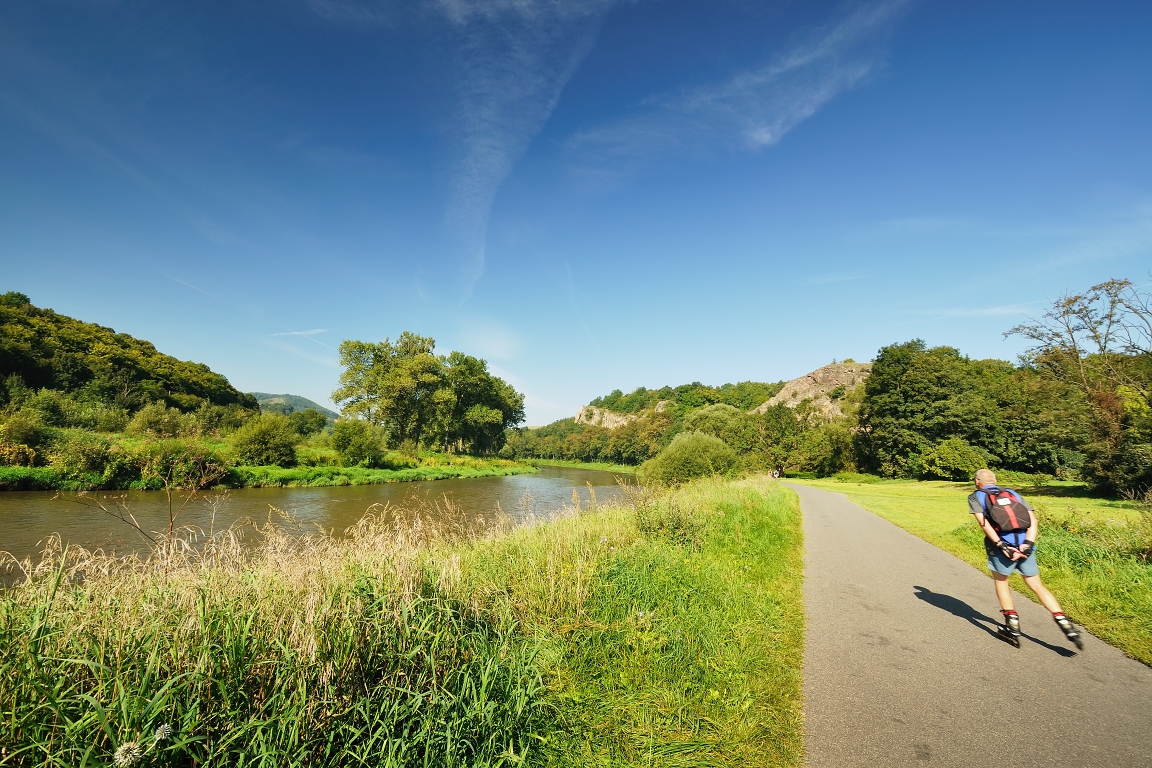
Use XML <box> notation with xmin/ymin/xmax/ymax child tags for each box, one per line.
<box><xmin>0</xmin><ymin>466</ymin><xmax>620</xmax><ymax>560</ymax></box>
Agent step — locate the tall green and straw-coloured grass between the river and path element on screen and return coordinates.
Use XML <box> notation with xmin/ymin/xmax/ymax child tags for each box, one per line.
<box><xmin>0</xmin><ymin>478</ymin><xmax>804</xmax><ymax>766</ymax></box>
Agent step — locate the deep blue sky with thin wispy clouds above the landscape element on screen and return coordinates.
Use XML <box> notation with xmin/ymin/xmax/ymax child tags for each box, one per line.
<box><xmin>0</xmin><ymin>0</ymin><xmax>1152</xmax><ymax>424</ymax></box>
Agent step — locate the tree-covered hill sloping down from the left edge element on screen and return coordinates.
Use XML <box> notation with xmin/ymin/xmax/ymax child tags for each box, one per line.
<box><xmin>0</xmin><ymin>291</ymin><xmax>256</xmax><ymax>410</ymax></box>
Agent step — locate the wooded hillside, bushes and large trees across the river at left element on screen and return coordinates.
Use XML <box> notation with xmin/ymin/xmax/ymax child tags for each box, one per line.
<box><xmin>0</xmin><ymin>292</ymin><xmax>523</xmax><ymax>489</ymax></box>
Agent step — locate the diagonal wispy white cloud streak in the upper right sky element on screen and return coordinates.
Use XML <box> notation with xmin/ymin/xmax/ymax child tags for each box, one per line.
<box><xmin>570</xmin><ymin>0</ymin><xmax>911</xmax><ymax>170</ymax></box>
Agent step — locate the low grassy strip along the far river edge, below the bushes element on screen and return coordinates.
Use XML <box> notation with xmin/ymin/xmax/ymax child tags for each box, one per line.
<box><xmin>0</xmin><ymin>456</ymin><xmax>537</xmax><ymax>491</ymax></box>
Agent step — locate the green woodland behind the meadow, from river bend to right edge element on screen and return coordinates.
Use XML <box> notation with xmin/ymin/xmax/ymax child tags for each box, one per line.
<box><xmin>502</xmin><ymin>280</ymin><xmax>1152</xmax><ymax>493</ymax></box>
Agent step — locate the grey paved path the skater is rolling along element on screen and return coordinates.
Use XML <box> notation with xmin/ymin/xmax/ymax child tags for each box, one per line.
<box><xmin>790</xmin><ymin>485</ymin><xmax>1152</xmax><ymax>768</ymax></box>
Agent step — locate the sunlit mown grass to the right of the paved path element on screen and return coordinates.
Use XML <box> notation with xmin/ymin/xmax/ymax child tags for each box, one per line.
<box><xmin>795</xmin><ymin>479</ymin><xmax>1152</xmax><ymax>666</ymax></box>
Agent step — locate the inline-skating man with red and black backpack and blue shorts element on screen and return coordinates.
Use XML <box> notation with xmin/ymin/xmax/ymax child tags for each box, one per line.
<box><xmin>968</xmin><ymin>470</ymin><xmax>1084</xmax><ymax>648</ymax></box>
